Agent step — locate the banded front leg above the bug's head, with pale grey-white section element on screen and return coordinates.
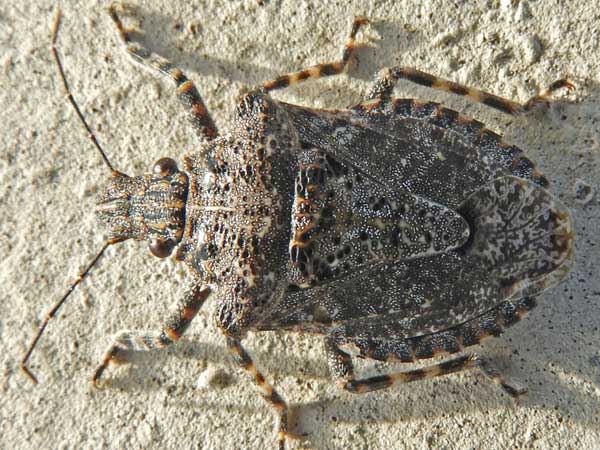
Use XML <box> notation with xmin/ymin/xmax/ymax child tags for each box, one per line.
<box><xmin>108</xmin><ymin>4</ymin><xmax>218</xmax><ymax>141</ymax></box>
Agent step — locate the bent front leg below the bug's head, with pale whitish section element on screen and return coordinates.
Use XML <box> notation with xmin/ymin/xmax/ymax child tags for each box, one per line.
<box><xmin>92</xmin><ymin>285</ymin><xmax>210</xmax><ymax>385</ymax></box>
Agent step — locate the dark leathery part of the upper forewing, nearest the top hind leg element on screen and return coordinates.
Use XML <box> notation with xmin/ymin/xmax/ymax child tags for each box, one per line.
<box><xmin>284</xmin><ymin>99</ymin><xmax>547</xmax><ymax>208</ymax></box>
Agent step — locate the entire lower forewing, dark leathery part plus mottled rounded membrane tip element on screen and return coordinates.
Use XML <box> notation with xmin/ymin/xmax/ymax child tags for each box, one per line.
<box><xmin>257</xmin><ymin>176</ymin><xmax>574</xmax><ymax>342</ymax></box>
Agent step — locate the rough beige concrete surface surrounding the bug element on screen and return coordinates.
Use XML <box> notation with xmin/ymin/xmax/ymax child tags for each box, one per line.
<box><xmin>0</xmin><ymin>0</ymin><xmax>600</xmax><ymax>450</ymax></box>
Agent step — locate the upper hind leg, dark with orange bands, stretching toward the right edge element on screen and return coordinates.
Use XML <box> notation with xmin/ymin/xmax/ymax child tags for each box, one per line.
<box><xmin>368</xmin><ymin>67</ymin><xmax>575</xmax><ymax>115</ymax></box>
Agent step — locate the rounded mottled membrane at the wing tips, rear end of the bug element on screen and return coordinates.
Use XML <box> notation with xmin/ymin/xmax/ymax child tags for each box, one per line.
<box><xmin>458</xmin><ymin>176</ymin><xmax>575</xmax><ymax>299</ymax></box>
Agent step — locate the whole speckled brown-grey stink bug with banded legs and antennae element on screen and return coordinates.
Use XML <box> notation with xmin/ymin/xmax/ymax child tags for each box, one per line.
<box><xmin>22</xmin><ymin>6</ymin><xmax>574</xmax><ymax>449</ymax></box>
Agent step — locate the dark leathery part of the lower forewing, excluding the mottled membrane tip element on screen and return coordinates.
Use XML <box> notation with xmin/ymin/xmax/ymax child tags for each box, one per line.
<box><xmin>259</xmin><ymin>252</ymin><xmax>502</xmax><ymax>340</ymax></box>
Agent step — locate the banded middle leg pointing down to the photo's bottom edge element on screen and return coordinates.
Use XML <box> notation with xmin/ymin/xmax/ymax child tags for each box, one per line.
<box><xmin>227</xmin><ymin>337</ymin><xmax>296</xmax><ymax>450</ymax></box>
